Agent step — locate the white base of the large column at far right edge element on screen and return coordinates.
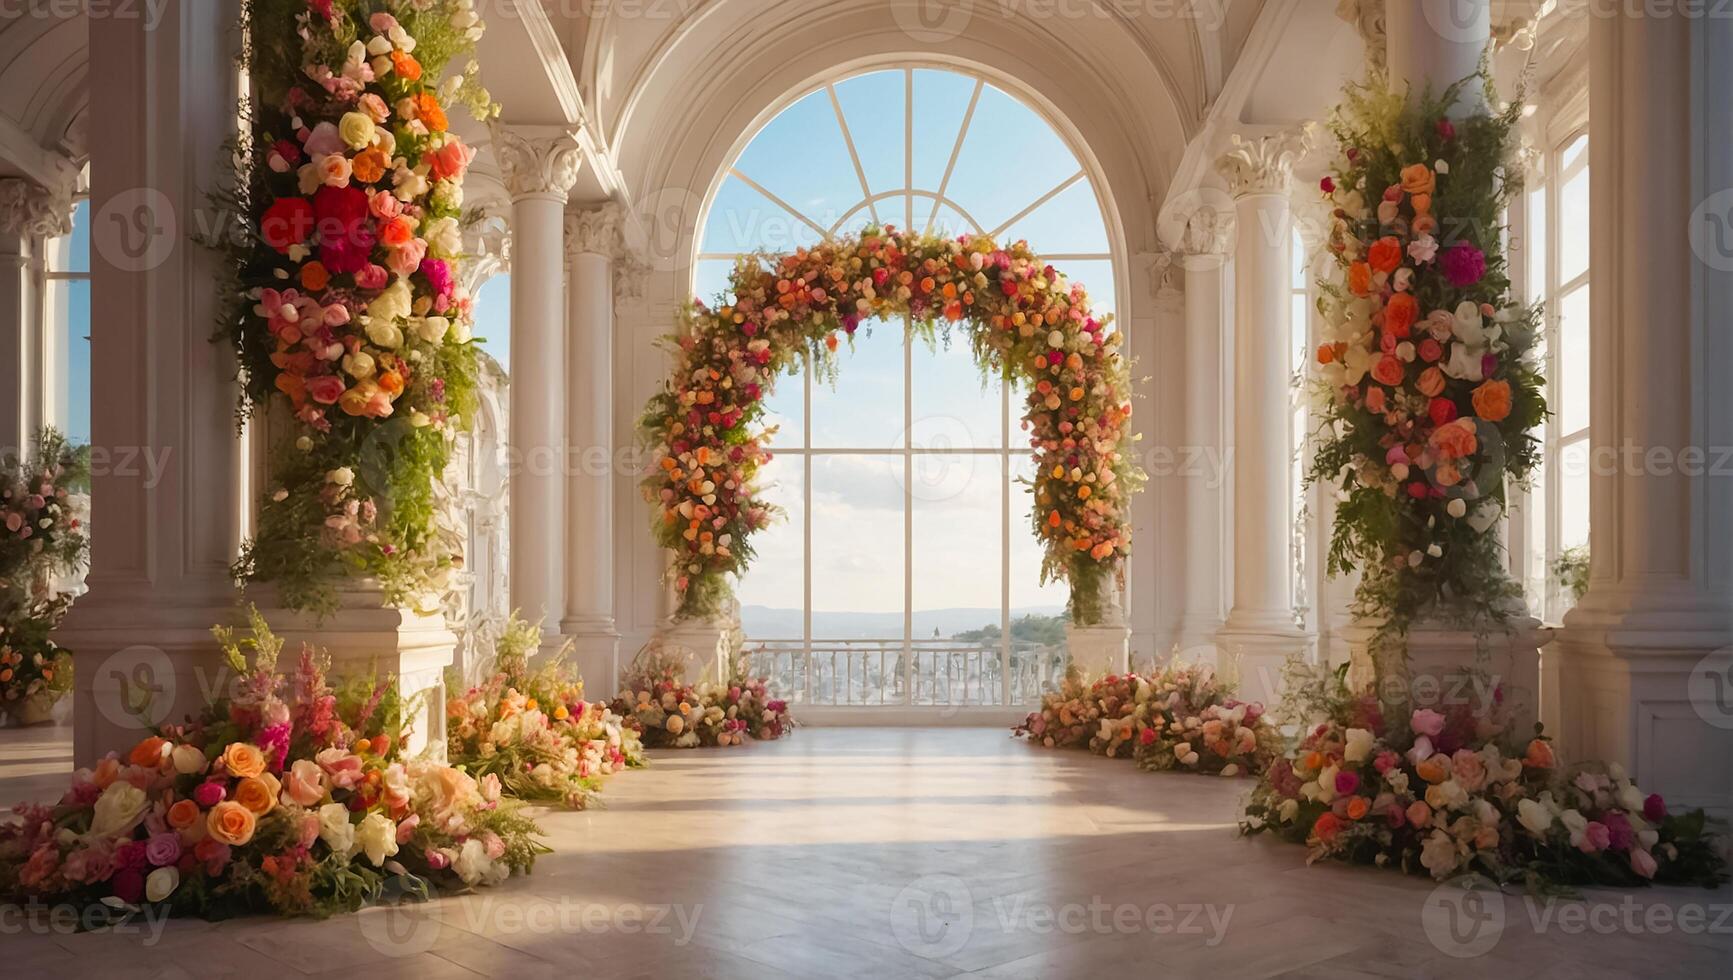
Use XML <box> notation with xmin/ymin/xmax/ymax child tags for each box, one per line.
<box><xmin>1546</xmin><ymin>605</ymin><xmax>1733</xmax><ymax>817</ymax></box>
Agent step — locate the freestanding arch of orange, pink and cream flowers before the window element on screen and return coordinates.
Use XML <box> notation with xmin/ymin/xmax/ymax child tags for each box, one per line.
<box><xmin>639</xmin><ymin>225</ymin><xmax>1144</xmax><ymax>626</ymax></box>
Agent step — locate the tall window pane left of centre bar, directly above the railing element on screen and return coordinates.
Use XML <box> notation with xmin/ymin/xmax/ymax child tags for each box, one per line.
<box><xmin>813</xmin><ymin>454</ymin><xmax>903</xmax><ymax>617</ymax></box>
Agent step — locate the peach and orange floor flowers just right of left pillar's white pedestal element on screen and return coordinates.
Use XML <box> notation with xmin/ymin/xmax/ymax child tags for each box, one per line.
<box><xmin>445</xmin><ymin>617</ymin><xmax>643</xmax><ymax>810</ymax></box>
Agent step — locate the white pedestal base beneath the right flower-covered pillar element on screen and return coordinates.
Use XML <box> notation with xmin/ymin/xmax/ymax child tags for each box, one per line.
<box><xmin>1341</xmin><ymin>616</ymin><xmax>1553</xmax><ymax>741</ymax></box>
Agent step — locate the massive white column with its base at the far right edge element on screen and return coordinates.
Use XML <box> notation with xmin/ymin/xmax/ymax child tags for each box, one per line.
<box><xmin>1556</xmin><ymin>7</ymin><xmax>1733</xmax><ymax>813</ymax></box>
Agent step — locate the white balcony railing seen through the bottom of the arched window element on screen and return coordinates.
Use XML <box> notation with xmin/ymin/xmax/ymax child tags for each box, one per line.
<box><xmin>743</xmin><ymin>638</ymin><xmax>1066</xmax><ymax>708</ymax></box>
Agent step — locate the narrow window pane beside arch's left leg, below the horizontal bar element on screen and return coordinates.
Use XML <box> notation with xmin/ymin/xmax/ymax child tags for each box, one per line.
<box><xmin>735</xmin><ymin>456</ymin><xmax>806</xmax><ymax>640</ymax></box>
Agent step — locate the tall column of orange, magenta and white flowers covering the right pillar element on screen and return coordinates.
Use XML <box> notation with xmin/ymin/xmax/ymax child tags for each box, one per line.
<box><xmin>1308</xmin><ymin>76</ymin><xmax>1548</xmax><ymax>635</ymax></box>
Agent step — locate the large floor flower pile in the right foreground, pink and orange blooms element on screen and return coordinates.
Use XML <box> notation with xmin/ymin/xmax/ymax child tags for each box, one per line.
<box><xmin>1241</xmin><ymin>664</ymin><xmax>1726</xmax><ymax>888</ymax></box>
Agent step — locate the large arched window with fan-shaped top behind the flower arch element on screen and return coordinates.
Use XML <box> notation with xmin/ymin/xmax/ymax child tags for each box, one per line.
<box><xmin>693</xmin><ymin>68</ymin><xmax>1114</xmax><ymax>704</ymax></box>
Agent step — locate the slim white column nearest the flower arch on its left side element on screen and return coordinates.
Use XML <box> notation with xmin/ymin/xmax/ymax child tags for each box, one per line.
<box><xmin>560</xmin><ymin>205</ymin><xmax>622</xmax><ymax>696</ymax></box>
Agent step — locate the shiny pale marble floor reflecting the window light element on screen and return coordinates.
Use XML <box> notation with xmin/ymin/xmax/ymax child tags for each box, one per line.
<box><xmin>0</xmin><ymin>728</ymin><xmax>1733</xmax><ymax>980</ymax></box>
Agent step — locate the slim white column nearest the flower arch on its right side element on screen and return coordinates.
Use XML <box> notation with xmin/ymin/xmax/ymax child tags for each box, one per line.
<box><xmin>1178</xmin><ymin>208</ymin><xmax>1232</xmax><ymax>656</ymax></box>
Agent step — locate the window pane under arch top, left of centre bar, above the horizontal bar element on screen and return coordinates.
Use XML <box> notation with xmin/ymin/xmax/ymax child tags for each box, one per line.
<box><xmin>813</xmin><ymin>319</ymin><xmax>905</xmax><ymax>449</ymax></box>
